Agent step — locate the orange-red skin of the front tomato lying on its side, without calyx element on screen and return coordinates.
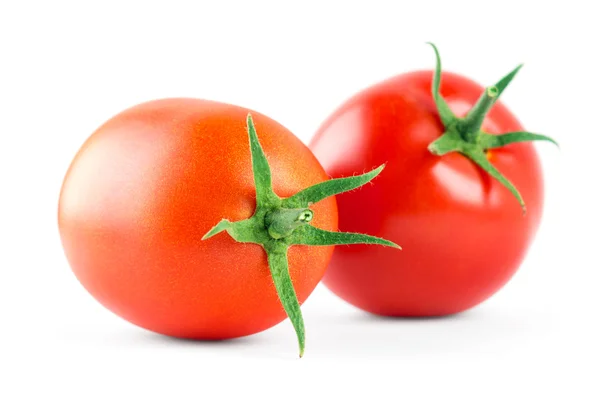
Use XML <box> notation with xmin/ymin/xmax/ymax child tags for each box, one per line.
<box><xmin>58</xmin><ymin>99</ymin><xmax>337</xmax><ymax>339</ymax></box>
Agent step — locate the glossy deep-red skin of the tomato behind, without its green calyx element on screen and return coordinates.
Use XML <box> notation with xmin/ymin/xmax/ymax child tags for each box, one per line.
<box><xmin>310</xmin><ymin>71</ymin><xmax>543</xmax><ymax>316</ymax></box>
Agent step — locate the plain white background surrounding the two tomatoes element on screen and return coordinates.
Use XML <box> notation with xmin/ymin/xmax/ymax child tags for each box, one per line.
<box><xmin>0</xmin><ymin>0</ymin><xmax>600</xmax><ymax>400</ymax></box>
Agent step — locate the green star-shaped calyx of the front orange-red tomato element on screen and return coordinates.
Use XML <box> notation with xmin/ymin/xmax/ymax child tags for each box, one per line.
<box><xmin>202</xmin><ymin>115</ymin><xmax>400</xmax><ymax>357</ymax></box>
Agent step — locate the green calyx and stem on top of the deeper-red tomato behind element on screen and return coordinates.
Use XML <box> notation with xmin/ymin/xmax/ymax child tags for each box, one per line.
<box><xmin>428</xmin><ymin>43</ymin><xmax>558</xmax><ymax>213</ymax></box>
